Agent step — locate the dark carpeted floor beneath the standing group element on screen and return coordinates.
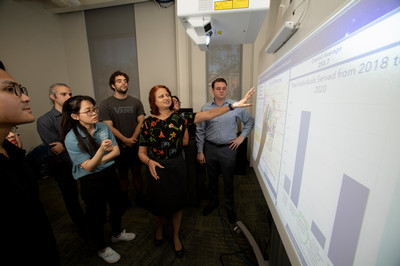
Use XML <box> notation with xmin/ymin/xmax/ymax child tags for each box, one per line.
<box><xmin>38</xmin><ymin>164</ymin><xmax>270</xmax><ymax>266</ymax></box>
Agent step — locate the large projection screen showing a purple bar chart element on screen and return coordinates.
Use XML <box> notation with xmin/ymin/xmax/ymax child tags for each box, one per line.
<box><xmin>251</xmin><ymin>0</ymin><xmax>400</xmax><ymax>265</ymax></box>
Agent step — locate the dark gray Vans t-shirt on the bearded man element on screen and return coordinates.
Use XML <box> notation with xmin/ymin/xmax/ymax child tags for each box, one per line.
<box><xmin>99</xmin><ymin>96</ymin><xmax>146</xmax><ymax>138</ymax></box>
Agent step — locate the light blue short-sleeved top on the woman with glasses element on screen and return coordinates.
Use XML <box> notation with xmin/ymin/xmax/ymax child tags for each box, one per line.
<box><xmin>65</xmin><ymin>122</ymin><xmax>117</xmax><ymax>180</ymax></box>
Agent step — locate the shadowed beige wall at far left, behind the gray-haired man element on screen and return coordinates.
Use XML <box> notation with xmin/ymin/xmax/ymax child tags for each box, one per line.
<box><xmin>0</xmin><ymin>0</ymin><xmax>75</xmax><ymax>150</ymax></box>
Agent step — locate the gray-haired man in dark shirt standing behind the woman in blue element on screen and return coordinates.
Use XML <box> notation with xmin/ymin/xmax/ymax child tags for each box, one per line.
<box><xmin>37</xmin><ymin>83</ymin><xmax>86</xmax><ymax>237</ymax></box>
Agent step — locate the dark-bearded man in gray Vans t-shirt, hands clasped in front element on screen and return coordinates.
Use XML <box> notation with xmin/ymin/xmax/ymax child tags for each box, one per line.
<box><xmin>99</xmin><ymin>71</ymin><xmax>145</xmax><ymax>209</ymax></box>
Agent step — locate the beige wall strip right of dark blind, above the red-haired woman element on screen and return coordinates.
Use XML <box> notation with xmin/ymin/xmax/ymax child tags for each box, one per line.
<box><xmin>135</xmin><ymin>2</ymin><xmax>177</xmax><ymax>115</ymax></box>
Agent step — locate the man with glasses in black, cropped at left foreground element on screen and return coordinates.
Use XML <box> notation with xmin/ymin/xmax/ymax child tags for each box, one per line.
<box><xmin>0</xmin><ymin>62</ymin><xmax>60</xmax><ymax>265</ymax></box>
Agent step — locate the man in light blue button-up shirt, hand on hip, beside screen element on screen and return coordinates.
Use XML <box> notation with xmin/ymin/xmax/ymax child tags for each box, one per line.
<box><xmin>196</xmin><ymin>78</ymin><xmax>254</xmax><ymax>223</ymax></box>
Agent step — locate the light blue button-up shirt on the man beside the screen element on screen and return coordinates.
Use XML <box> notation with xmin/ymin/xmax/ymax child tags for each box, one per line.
<box><xmin>196</xmin><ymin>99</ymin><xmax>254</xmax><ymax>152</ymax></box>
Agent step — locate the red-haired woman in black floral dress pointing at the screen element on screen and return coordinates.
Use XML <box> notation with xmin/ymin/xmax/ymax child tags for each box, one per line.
<box><xmin>139</xmin><ymin>85</ymin><xmax>255</xmax><ymax>258</ymax></box>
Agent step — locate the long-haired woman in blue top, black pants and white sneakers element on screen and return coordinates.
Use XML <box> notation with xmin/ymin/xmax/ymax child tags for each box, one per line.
<box><xmin>61</xmin><ymin>96</ymin><xmax>135</xmax><ymax>263</ymax></box>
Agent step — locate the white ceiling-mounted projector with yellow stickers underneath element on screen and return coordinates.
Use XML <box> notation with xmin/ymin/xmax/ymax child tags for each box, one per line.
<box><xmin>177</xmin><ymin>0</ymin><xmax>269</xmax><ymax>51</ymax></box>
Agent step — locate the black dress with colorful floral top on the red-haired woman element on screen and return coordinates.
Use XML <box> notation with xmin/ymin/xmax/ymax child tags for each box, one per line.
<box><xmin>139</xmin><ymin>113</ymin><xmax>196</xmax><ymax>217</ymax></box>
